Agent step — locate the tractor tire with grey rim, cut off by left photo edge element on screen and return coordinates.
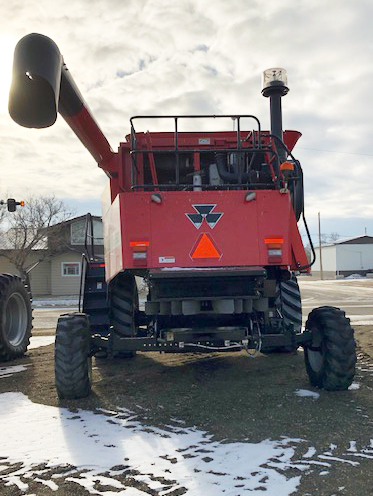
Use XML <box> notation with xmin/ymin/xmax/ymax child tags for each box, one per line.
<box><xmin>0</xmin><ymin>274</ymin><xmax>32</xmax><ymax>361</ymax></box>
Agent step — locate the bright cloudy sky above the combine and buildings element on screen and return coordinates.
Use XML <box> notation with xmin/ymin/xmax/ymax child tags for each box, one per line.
<box><xmin>0</xmin><ymin>0</ymin><xmax>373</xmax><ymax>237</ymax></box>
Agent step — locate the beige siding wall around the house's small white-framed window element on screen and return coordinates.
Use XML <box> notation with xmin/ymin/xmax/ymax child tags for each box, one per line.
<box><xmin>51</xmin><ymin>252</ymin><xmax>81</xmax><ymax>296</ymax></box>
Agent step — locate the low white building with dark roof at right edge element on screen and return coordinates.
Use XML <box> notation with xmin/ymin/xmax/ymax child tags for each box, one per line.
<box><xmin>312</xmin><ymin>236</ymin><xmax>373</xmax><ymax>279</ymax></box>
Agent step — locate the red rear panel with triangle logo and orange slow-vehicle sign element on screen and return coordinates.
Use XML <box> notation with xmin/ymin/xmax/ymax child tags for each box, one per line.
<box><xmin>120</xmin><ymin>190</ymin><xmax>296</xmax><ymax>269</ymax></box>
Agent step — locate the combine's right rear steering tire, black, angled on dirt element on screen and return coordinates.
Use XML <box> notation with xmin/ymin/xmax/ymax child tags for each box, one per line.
<box><xmin>304</xmin><ymin>307</ymin><xmax>356</xmax><ymax>391</ymax></box>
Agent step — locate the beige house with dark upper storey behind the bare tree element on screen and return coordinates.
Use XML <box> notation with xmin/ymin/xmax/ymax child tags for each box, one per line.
<box><xmin>0</xmin><ymin>215</ymin><xmax>104</xmax><ymax>296</ymax></box>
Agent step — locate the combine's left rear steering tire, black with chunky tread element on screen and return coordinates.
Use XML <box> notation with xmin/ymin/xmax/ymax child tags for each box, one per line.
<box><xmin>54</xmin><ymin>313</ymin><xmax>92</xmax><ymax>399</ymax></box>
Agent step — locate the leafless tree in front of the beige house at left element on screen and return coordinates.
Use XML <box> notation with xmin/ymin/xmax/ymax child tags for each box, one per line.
<box><xmin>2</xmin><ymin>196</ymin><xmax>73</xmax><ymax>280</ymax></box>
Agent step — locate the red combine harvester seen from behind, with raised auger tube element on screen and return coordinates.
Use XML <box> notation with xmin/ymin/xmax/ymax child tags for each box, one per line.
<box><xmin>9</xmin><ymin>34</ymin><xmax>356</xmax><ymax>398</ymax></box>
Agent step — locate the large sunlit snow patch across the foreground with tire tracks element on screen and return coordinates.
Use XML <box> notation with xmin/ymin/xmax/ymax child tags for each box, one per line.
<box><xmin>0</xmin><ymin>393</ymin><xmax>309</xmax><ymax>496</ymax></box>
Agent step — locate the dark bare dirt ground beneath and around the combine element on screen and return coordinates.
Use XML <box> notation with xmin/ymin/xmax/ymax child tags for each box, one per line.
<box><xmin>0</xmin><ymin>326</ymin><xmax>373</xmax><ymax>496</ymax></box>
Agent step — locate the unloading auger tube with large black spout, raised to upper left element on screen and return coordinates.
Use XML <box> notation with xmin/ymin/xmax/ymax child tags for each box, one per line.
<box><xmin>9</xmin><ymin>33</ymin><xmax>116</xmax><ymax>177</ymax></box>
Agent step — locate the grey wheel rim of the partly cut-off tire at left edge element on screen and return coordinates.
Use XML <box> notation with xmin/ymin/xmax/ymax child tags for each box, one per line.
<box><xmin>5</xmin><ymin>293</ymin><xmax>28</xmax><ymax>346</ymax></box>
